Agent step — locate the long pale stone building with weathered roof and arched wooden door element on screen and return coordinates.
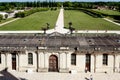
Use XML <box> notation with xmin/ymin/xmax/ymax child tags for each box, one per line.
<box><xmin>0</xmin><ymin>33</ymin><xmax>120</xmax><ymax>73</ymax></box>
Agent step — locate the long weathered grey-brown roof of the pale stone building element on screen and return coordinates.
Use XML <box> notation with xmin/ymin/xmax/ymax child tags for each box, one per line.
<box><xmin>0</xmin><ymin>32</ymin><xmax>120</xmax><ymax>51</ymax></box>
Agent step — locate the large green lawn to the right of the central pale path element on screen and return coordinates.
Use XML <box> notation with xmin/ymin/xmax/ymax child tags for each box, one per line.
<box><xmin>64</xmin><ymin>10</ymin><xmax>120</xmax><ymax>30</ymax></box>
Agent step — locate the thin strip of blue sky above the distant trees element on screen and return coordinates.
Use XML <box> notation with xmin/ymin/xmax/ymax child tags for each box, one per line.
<box><xmin>0</xmin><ymin>0</ymin><xmax>120</xmax><ymax>2</ymax></box>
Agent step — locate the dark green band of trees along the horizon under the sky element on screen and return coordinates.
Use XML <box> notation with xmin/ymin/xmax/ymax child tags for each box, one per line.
<box><xmin>0</xmin><ymin>1</ymin><xmax>120</xmax><ymax>11</ymax></box>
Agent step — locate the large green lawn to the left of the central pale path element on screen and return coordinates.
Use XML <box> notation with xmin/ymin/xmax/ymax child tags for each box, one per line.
<box><xmin>0</xmin><ymin>10</ymin><xmax>59</xmax><ymax>30</ymax></box>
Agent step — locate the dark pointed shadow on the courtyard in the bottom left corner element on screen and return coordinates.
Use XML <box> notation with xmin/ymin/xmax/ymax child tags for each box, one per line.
<box><xmin>0</xmin><ymin>68</ymin><xmax>27</xmax><ymax>80</ymax></box>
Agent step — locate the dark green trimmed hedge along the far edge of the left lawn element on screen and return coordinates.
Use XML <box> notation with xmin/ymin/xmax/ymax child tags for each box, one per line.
<box><xmin>15</xmin><ymin>8</ymin><xmax>49</xmax><ymax>18</ymax></box>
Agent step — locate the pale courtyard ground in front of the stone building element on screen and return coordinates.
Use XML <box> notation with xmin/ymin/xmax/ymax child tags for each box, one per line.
<box><xmin>0</xmin><ymin>71</ymin><xmax>120</xmax><ymax>80</ymax></box>
